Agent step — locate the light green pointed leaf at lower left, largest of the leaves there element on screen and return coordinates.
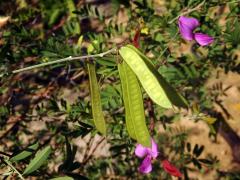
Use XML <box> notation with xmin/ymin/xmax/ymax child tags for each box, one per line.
<box><xmin>23</xmin><ymin>146</ymin><xmax>51</xmax><ymax>175</ymax></box>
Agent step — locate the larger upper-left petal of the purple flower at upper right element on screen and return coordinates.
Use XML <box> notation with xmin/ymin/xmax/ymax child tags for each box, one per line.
<box><xmin>178</xmin><ymin>16</ymin><xmax>200</xmax><ymax>41</ymax></box>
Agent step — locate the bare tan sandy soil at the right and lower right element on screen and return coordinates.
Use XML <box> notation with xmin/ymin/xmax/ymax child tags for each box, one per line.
<box><xmin>170</xmin><ymin>70</ymin><xmax>240</xmax><ymax>180</ymax></box>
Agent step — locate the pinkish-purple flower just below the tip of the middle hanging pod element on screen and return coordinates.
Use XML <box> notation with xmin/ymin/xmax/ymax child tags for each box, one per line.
<box><xmin>135</xmin><ymin>139</ymin><xmax>158</xmax><ymax>174</ymax></box>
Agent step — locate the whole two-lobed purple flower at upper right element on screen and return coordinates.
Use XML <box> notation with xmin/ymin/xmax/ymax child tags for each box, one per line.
<box><xmin>178</xmin><ymin>16</ymin><xmax>214</xmax><ymax>46</ymax></box>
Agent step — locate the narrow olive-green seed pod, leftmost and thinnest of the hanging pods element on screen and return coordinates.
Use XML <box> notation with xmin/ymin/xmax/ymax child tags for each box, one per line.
<box><xmin>87</xmin><ymin>63</ymin><xmax>107</xmax><ymax>135</ymax></box>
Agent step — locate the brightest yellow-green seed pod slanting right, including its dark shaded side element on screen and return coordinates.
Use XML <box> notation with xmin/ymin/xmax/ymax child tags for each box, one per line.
<box><xmin>119</xmin><ymin>45</ymin><xmax>187</xmax><ymax>108</ymax></box>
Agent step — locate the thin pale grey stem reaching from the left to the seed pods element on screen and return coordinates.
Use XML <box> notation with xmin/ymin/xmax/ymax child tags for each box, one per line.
<box><xmin>12</xmin><ymin>48</ymin><xmax>117</xmax><ymax>74</ymax></box>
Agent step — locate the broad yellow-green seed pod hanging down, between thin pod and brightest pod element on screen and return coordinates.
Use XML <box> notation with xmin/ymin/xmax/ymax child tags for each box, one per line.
<box><xmin>118</xmin><ymin>62</ymin><xmax>151</xmax><ymax>147</ymax></box>
